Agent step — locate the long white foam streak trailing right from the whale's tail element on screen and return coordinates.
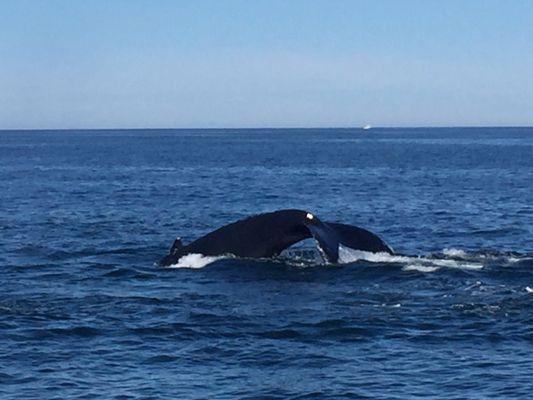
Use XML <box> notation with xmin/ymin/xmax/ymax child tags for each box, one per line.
<box><xmin>339</xmin><ymin>246</ymin><xmax>483</xmax><ymax>272</ymax></box>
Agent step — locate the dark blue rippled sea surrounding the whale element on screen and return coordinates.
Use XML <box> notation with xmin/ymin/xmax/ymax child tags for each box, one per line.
<box><xmin>0</xmin><ymin>128</ymin><xmax>533</xmax><ymax>399</ymax></box>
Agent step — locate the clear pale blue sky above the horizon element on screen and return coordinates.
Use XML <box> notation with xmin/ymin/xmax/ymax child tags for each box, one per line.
<box><xmin>0</xmin><ymin>0</ymin><xmax>533</xmax><ymax>129</ymax></box>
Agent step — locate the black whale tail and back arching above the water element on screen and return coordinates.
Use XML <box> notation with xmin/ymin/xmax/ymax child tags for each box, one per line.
<box><xmin>159</xmin><ymin>209</ymin><xmax>393</xmax><ymax>266</ymax></box>
